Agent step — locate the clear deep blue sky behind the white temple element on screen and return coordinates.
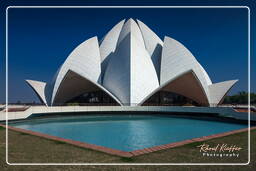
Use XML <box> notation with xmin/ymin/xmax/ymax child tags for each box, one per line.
<box><xmin>0</xmin><ymin>0</ymin><xmax>256</xmax><ymax>102</ymax></box>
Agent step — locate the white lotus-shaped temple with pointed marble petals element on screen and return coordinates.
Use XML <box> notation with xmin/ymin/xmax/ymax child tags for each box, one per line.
<box><xmin>26</xmin><ymin>19</ymin><xmax>238</xmax><ymax>106</ymax></box>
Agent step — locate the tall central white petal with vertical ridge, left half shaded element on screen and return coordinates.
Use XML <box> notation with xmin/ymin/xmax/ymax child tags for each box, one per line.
<box><xmin>103</xmin><ymin>19</ymin><xmax>159</xmax><ymax>105</ymax></box>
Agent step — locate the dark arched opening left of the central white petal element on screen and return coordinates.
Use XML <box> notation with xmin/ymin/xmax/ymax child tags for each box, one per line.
<box><xmin>53</xmin><ymin>70</ymin><xmax>119</xmax><ymax>106</ymax></box>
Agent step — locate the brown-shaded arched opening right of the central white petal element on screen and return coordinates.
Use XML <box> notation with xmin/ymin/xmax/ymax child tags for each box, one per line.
<box><xmin>142</xmin><ymin>70</ymin><xmax>209</xmax><ymax>106</ymax></box>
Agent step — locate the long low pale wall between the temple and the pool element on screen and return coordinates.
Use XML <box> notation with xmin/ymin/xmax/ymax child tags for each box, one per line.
<box><xmin>0</xmin><ymin>106</ymin><xmax>256</xmax><ymax>121</ymax></box>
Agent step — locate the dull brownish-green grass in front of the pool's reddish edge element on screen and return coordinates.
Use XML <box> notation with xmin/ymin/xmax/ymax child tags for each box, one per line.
<box><xmin>0</xmin><ymin>127</ymin><xmax>256</xmax><ymax>171</ymax></box>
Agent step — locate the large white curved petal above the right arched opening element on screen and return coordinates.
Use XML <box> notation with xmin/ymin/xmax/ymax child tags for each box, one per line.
<box><xmin>160</xmin><ymin>37</ymin><xmax>210</xmax><ymax>98</ymax></box>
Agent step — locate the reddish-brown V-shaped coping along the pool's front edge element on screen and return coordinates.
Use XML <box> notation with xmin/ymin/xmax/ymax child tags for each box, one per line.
<box><xmin>0</xmin><ymin>124</ymin><xmax>256</xmax><ymax>157</ymax></box>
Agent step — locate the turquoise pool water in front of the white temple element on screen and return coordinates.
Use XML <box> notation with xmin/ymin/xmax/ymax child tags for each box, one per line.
<box><xmin>10</xmin><ymin>115</ymin><xmax>247</xmax><ymax>151</ymax></box>
